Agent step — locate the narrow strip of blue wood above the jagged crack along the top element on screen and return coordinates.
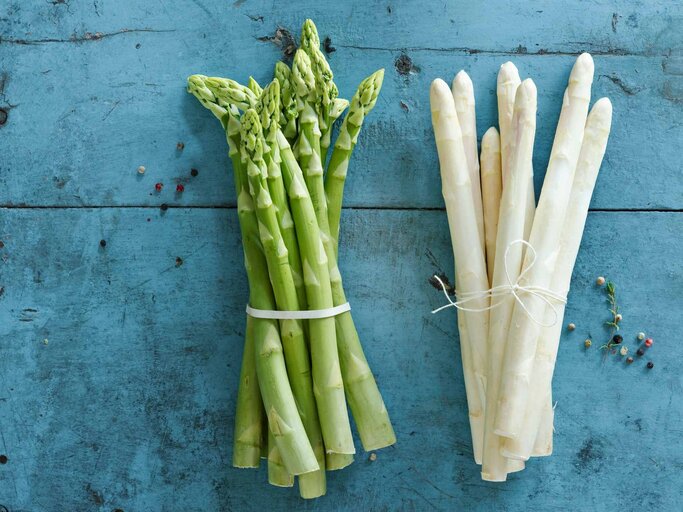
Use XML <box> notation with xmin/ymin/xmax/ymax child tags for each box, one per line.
<box><xmin>0</xmin><ymin>0</ymin><xmax>681</xmax><ymax>54</ymax></box>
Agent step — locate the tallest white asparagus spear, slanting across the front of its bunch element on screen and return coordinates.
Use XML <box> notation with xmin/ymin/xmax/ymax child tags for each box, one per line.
<box><xmin>495</xmin><ymin>53</ymin><xmax>594</xmax><ymax>438</ymax></box>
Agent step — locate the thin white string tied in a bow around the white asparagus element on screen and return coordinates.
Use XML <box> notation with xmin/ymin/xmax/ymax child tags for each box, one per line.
<box><xmin>432</xmin><ymin>240</ymin><xmax>567</xmax><ymax>327</ymax></box>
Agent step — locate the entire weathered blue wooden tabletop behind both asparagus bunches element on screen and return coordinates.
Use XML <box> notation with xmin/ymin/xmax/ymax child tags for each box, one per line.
<box><xmin>0</xmin><ymin>0</ymin><xmax>683</xmax><ymax>512</ymax></box>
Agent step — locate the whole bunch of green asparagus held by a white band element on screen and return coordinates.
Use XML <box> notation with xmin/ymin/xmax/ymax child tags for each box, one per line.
<box><xmin>188</xmin><ymin>20</ymin><xmax>396</xmax><ymax>498</ymax></box>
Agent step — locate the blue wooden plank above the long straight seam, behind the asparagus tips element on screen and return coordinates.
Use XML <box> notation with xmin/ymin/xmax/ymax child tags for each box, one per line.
<box><xmin>0</xmin><ymin>5</ymin><xmax>683</xmax><ymax>209</ymax></box>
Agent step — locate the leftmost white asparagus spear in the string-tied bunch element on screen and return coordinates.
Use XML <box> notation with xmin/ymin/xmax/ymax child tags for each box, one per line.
<box><xmin>429</xmin><ymin>79</ymin><xmax>489</xmax><ymax>460</ymax></box>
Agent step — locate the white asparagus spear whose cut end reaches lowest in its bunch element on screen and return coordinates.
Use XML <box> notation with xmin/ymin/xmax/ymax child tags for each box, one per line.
<box><xmin>481</xmin><ymin>79</ymin><xmax>537</xmax><ymax>482</ymax></box>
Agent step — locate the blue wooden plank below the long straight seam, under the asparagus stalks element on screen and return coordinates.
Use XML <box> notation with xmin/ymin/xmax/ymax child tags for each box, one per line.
<box><xmin>0</xmin><ymin>208</ymin><xmax>683</xmax><ymax>511</ymax></box>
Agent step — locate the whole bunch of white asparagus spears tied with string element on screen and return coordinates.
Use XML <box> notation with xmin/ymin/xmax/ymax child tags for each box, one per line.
<box><xmin>430</xmin><ymin>54</ymin><xmax>611</xmax><ymax>481</ymax></box>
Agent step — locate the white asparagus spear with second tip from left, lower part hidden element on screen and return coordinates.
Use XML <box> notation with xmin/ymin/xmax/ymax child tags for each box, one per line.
<box><xmin>451</xmin><ymin>70</ymin><xmax>486</xmax><ymax>255</ymax></box>
